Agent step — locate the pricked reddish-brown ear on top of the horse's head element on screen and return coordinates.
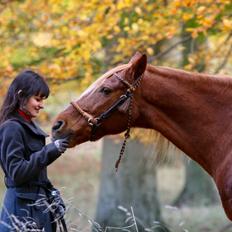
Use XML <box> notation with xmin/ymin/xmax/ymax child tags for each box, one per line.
<box><xmin>130</xmin><ymin>52</ymin><xmax>147</xmax><ymax>79</ymax></box>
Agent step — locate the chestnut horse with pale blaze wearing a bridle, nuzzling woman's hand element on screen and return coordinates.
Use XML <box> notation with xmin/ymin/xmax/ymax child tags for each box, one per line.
<box><xmin>52</xmin><ymin>53</ymin><xmax>232</xmax><ymax>220</ymax></box>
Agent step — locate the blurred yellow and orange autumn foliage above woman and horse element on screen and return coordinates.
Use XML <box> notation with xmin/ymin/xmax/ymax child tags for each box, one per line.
<box><xmin>0</xmin><ymin>0</ymin><xmax>232</xmax><ymax>87</ymax></box>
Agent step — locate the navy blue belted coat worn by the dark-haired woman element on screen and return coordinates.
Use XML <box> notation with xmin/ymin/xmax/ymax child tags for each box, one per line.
<box><xmin>0</xmin><ymin>115</ymin><xmax>60</xmax><ymax>232</ymax></box>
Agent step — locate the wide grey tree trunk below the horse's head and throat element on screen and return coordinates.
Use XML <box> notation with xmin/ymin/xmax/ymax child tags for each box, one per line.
<box><xmin>96</xmin><ymin>137</ymin><xmax>164</xmax><ymax>231</ymax></box>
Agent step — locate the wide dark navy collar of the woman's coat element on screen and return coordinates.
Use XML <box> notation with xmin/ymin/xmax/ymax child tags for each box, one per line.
<box><xmin>10</xmin><ymin>113</ymin><xmax>49</xmax><ymax>137</ymax></box>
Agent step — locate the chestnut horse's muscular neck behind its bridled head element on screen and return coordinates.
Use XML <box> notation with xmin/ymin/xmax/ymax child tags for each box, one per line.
<box><xmin>135</xmin><ymin>66</ymin><xmax>232</xmax><ymax>174</ymax></box>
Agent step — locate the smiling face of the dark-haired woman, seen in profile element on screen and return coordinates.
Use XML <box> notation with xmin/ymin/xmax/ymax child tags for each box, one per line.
<box><xmin>24</xmin><ymin>96</ymin><xmax>44</xmax><ymax>118</ymax></box>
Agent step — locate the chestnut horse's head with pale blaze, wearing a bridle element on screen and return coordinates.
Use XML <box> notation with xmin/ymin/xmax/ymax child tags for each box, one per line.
<box><xmin>52</xmin><ymin>53</ymin><xmax>147</xmax><ymax>147</ymax></box>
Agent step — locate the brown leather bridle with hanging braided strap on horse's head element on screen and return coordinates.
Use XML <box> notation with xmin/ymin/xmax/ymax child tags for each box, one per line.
<box><xmin>70</xmin><ymin>73</ymin><xmax>143</xmax><ymax>171</ymax></box>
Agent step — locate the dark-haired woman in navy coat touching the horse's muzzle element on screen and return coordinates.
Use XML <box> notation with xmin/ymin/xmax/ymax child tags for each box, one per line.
<box><xmin>0</xmin><ymin>70</ymin><xmax>68</xmax><ymax>232</ymax></box>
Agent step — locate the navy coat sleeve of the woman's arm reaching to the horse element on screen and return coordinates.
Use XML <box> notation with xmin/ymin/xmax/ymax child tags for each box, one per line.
<box><xmin>0</xmin><ymin>122</ymin><xmax>61</xmax><ymax>185</ymax></box>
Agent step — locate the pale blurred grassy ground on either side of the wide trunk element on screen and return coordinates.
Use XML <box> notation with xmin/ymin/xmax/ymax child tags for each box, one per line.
<box><xmin>0</xmin><ymin>141</ymin><xmax>232</xmax><ymax>232</ymax></box>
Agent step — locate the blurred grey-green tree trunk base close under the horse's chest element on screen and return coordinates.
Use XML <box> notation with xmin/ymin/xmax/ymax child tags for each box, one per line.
<box><xmin>174</xmin><ymin>160</ymin><xmax>219</xmax><ymax>206</ymax></box>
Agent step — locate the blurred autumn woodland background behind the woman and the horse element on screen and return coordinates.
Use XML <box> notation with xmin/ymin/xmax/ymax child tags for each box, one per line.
<box><xmin>0</xmin><ymin>0</ymin><xmax>232</xmax><ymax>232</ymax></box>
